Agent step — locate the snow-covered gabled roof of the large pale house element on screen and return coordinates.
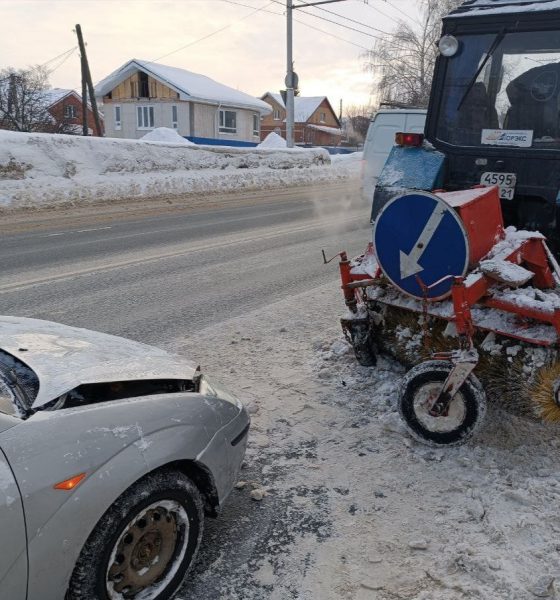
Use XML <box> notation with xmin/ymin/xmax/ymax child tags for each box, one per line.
<box><xmin>95</xmin><ymin>58</ymin><xmax>271</xmax><ymax>114</ymax></box>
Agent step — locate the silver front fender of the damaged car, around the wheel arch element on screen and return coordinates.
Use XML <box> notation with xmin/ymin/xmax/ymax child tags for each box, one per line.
<box><xmin>3</xmin><ymin>395</ymin><xmax>239</xmax><ymax>600</ymax></box>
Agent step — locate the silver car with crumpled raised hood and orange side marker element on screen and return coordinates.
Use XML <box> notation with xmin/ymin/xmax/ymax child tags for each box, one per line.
<box><xmin>0</xmin><ymin>317</ymin><xmax>249</xmax><ymax>600</ymax></box>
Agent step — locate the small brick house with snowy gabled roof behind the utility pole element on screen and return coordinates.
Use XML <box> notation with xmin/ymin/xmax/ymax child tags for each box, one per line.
<box><xmin>261</xmin><ymin>92</ymin><xmax>343</xmax><ymax>146</ymax></box>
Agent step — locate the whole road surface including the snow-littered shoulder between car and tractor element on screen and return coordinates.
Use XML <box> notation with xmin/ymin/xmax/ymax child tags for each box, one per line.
<box><xmin>0</xmin><ymin>179</ymin><xmax>560</xmax><ymax>600</ymax></box>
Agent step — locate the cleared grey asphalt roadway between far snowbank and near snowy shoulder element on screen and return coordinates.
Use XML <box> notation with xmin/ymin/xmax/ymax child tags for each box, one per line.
<box><xmin>0</xmin><ymin>180</ymin><xmax>368</xmax><ymax>345</ymax></box>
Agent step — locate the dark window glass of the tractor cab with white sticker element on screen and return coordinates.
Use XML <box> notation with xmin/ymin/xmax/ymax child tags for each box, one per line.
<box><xmin>436</xmin><ymin>31</ymin><xmax>560</xmax><ymax>149</ymax></box>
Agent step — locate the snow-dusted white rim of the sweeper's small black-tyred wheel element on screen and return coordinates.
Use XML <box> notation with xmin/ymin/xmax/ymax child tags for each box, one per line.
<box><xmin>414</xmin><ymin>381</ymin><xmax>467</xmax><ymax>433</ymax></box>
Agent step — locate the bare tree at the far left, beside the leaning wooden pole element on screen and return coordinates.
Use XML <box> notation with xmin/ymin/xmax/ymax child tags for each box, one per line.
<box><xmin>0</xmin><ymin>67</ymin><xmax>67</xmax><ymax>133</ymax></box>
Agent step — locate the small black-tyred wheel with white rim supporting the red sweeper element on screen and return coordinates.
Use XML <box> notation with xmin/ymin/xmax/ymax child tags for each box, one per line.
<box><xmin>398</xmin><ymin>360</ymin><xmax>486</xmax><ymax>446</ymax></box>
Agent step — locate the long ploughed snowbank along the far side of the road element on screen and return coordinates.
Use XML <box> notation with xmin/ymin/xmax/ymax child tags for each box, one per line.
<box><xmin>0</xmin><ymin>130</ymin><xmax>360</xmax><ymax>210</ymax></box>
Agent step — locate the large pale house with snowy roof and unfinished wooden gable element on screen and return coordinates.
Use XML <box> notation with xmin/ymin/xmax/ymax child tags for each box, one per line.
<box><xmin>95</xmin><ymin>59</ymin><xmax>271</xmax><ymax>146</ymax></box>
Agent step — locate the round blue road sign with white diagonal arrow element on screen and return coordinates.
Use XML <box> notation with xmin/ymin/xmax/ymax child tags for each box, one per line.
<box><xmin>373</xmin><ymin>191</ymin><xmax>469</xmax><ymax>300</ymax></box>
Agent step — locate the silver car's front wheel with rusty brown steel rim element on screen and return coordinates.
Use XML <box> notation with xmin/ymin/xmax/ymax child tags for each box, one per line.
<box><xmin>66</xmin><ymin>470</ymin><xmax>204</xmax><ymax>600</ymax></box>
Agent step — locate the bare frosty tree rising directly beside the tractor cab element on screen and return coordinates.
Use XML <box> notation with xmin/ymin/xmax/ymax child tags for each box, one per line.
<box><xmin>366</xmin><ymin>0</ymin><xmax>462</xmax><ymax>107</ymax></box>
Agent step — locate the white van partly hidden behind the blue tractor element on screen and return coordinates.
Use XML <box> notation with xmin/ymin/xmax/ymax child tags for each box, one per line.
<box><xmin>362</xmin><ymin>108</ymin><xmax>426</xmax><ymax>202</ymax></box>
